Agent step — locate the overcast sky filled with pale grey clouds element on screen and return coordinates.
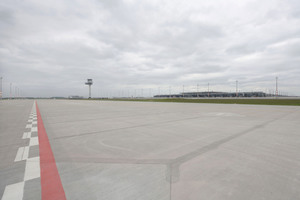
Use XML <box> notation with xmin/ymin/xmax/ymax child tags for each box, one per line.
<box><xmin>0</xmin><ymin>0</ymin><xmax>300</xmax><ymax>97</ymax></box>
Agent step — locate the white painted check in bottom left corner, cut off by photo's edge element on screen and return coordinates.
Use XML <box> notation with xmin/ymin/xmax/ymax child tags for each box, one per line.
<box><xmin>2</xmin><ymin>182</ymin><xmax>24</xmax><ymax>200</ymax></box>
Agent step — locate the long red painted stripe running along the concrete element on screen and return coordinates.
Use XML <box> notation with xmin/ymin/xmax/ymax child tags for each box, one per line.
<box><xmin>36</xmin><ymin>103</ymin><xmax>66</xmax><ymax>200</ymax></box>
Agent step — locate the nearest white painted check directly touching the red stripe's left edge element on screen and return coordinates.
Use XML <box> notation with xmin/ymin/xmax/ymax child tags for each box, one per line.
<box><xmin>24</xmin><ymin>157</ymin><xmax>40</xmax><ymax>181</ymax></box>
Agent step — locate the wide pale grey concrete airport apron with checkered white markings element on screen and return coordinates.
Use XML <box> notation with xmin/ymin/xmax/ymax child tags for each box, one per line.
<box><xmin>0</xmin><ymin>100</ymin><xmax>300</xmax><ymax>200</ymax></box>
